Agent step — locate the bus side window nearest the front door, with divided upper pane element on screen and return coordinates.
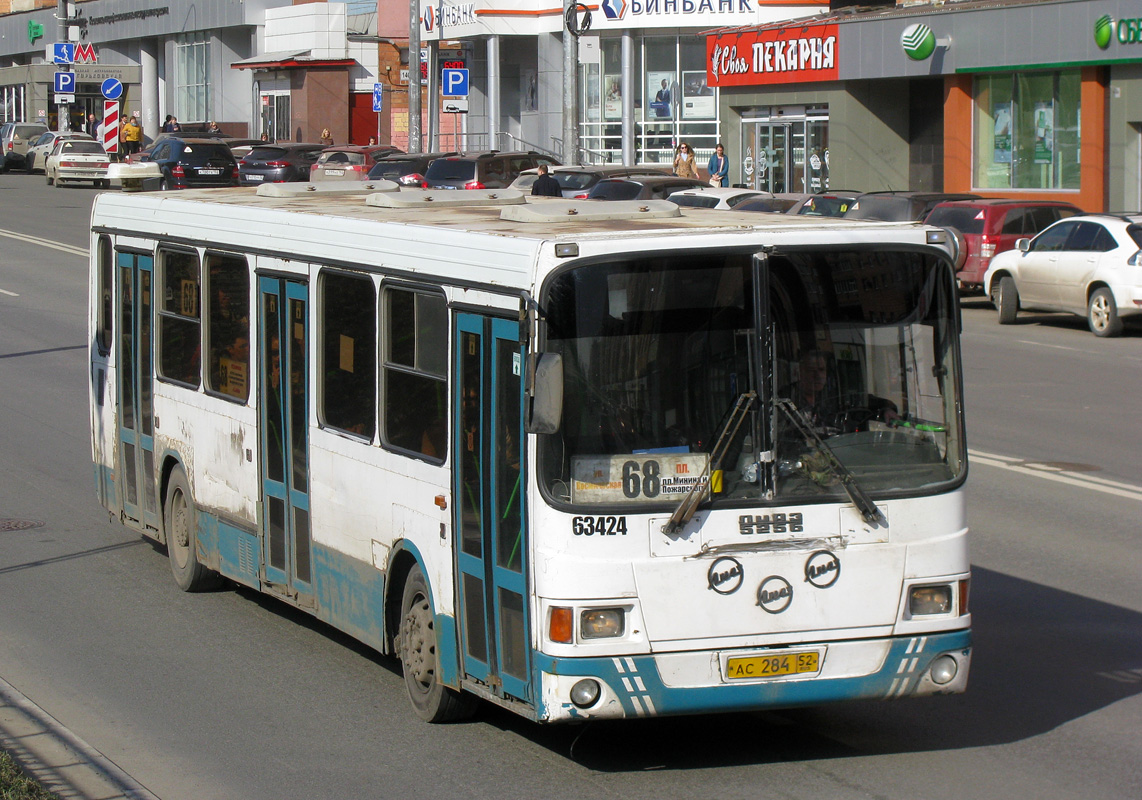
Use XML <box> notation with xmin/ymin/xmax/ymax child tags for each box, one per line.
<box><xmin>381</xmin><ymin>286</ymin><xmax>448</xmax><ymax>461</ymax></box>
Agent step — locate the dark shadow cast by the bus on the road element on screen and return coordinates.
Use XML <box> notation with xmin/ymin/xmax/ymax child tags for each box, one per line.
<box><xmin>484</xmin><ymin>568</ymin><xmax>1142</xmax><ymax>773</ymax></box>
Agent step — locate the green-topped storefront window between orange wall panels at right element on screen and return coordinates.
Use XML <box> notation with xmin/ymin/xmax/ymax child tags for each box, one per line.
<box><xmin>973</xmin><ymin>70</ymin><xmax>1081</xmax><ymax>189</ymax></box>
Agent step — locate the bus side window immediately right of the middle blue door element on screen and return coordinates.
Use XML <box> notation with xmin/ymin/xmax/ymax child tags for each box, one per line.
<box><xmin>320</xmin><ymin>272</ymin><xmax>377</xmax><ymax>441</ymax></box>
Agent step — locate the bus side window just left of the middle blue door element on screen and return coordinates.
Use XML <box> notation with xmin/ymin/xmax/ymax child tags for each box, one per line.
<box><xmin>206</xmin><ymin>253</ymin><xmax>250</xmax><ymax>403</ymax></box>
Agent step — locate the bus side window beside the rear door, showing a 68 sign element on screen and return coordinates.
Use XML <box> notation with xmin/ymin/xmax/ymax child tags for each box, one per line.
<box><xmin>159</xmin><ymin>250</ymin><xmax>202</xmax><ymax>388</ymax></box>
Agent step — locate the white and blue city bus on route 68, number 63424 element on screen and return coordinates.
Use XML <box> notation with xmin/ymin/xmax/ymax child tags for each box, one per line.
<box><xmin>90</xmin><ymin>181</ymin><xmax>971</xmax><ymax>722</ymax></box>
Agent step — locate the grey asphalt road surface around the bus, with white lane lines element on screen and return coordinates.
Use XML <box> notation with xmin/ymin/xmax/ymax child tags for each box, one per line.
<box><xmin>0</xmin><ymin>173</ymin><xmax>1142</xmax><ymax>800</ymax></box>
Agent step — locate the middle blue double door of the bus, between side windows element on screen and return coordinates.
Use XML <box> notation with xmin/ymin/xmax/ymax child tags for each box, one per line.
<box><xmin>258</xmin><ymin>277</ymin><xmax>313</xmax><ymax>605</ymax></box>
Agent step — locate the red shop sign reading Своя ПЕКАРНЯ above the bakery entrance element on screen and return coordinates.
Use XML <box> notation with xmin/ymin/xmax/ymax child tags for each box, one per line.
<box><xmin>706</xmin><ymin>24</ymin><xmax>839</xmax><ymax>86</ymax></box>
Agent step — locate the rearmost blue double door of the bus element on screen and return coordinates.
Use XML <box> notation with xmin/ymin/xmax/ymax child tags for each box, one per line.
<box><xmin>115</xmin><ymin>252</ymin><xmax>159</xmax><ymax>531</ymax></box>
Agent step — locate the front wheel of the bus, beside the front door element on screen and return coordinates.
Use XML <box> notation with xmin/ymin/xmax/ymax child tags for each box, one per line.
<box><xmin>400</xmin><ymin>566</ymin><xmax>476</xmax><ymax>722</ymax></box>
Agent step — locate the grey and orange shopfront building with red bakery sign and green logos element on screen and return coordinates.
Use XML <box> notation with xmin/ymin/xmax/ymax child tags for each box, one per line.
<box><xmin>707</xmin><ymin>0</ymin><xmax>1142</xmax><ymax>211</ymax></box>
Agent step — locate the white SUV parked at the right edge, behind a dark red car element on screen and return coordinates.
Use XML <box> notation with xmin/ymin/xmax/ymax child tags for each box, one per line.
<box><xmin>983</xmin><ymin>215</ymin><xmax>1142</xmax><ymax>337</ymax></box>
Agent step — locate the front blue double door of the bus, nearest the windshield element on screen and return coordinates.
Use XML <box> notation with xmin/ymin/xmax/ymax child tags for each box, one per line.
<box><xmin>452</xmin><ymin>314</ymin><xmax>530</xmax><ymax>701</ymax></box>
